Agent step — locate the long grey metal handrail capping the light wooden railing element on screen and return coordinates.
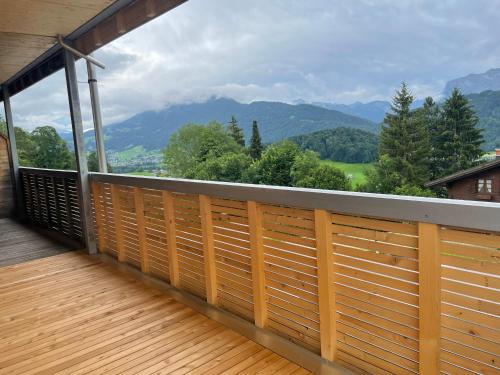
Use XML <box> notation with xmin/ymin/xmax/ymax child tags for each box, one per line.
<box><xmin>90</xmin><ymin>173</ymin><xmax>500</xmax><ymax>232</ymax></box>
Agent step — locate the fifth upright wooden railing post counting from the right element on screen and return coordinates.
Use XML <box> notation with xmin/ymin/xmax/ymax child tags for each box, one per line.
<box><xmin>162</xmin><ymin>191</ymin><xmax>180</xmax><ymax>288</ymax></box>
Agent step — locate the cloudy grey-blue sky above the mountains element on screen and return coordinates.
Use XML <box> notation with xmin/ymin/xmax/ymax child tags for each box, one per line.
<box><xmin>3</xmin><ymin>0</ymin><xmax>500</xmax><ymax>129</ymax></box>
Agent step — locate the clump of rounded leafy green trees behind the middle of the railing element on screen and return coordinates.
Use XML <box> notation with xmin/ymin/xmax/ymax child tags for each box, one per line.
<box><xmin>164</xmin><ymin>117</ymin><xmax>351</xmax><ymax>190</ymax></box>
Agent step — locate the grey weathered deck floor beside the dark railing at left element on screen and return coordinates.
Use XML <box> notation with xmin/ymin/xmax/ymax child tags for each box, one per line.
<box><xmin>0</xmin><ymin>218</ymin><xmax>73</xmax><ymax>267</ymax></box>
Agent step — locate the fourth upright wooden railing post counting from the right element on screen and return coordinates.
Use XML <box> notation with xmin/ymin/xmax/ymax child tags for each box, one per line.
<box><xmin>200</xmin><ymin>194</ymin><xmax>217</xmax><ymax>305</ymax></box>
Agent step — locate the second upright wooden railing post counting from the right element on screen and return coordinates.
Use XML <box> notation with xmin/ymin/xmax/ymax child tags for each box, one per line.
<box><xmin>314</xmin><ymin>210</ymin><xmax>337</xmax><ymax>361</ymax></box>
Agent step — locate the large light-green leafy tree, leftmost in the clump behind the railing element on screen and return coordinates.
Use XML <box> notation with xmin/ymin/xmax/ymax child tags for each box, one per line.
<box><xmin>164</xmin><ymin>122</ymin><xmax>243</xmax><ymax>177</ymax></box>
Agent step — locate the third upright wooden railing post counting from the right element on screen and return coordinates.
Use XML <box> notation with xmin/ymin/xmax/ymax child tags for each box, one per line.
<box><xmin>247</xmin><ymin>201</ymin><xmax>267</xmax><ymax>328</ymax></box>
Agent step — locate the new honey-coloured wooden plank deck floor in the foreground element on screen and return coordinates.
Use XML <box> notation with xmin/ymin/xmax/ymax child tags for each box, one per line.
<box><xmin>0</xmin><ymin>252</ymin><xmax>309</xmax><ymax>375</ymax></box>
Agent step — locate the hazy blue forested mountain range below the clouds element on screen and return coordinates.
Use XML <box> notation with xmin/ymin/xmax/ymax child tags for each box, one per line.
<box><xmin>61</xmin><ymin>69</ymin><xmax>500</xmax><ymax>162</ymax></box>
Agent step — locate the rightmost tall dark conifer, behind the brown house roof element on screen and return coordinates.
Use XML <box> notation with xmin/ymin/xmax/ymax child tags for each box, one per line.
<box><xmin>433</xmin><ymin>89</ymin><xmax>484</xmax><ymax>178</ymax></box>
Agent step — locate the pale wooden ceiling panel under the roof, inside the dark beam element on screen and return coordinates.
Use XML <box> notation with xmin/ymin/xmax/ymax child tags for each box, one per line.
<box><xmin>0</xmin><ymin>0</ymin><xmax>114</xmax><ymax>82</ymax></box>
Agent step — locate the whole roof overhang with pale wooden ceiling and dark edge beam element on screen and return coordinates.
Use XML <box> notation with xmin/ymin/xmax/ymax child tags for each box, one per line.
<box><xmin>0</xmin><ymin>0</ymin><xmax>187</xmax><ymax>101</ymax></box>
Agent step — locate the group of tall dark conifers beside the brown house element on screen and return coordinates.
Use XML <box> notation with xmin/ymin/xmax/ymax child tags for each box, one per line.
<box><xmin>359</xmin><ymin>83</ymin><xmax>484</xmax><ymax>196</ymax></box>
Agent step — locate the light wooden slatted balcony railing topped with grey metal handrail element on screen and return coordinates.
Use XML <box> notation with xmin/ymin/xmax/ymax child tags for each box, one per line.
<box><xmin>15</xmin><ymin>171</ymin><xmax>500</xmax><ymax>374</ymax></box>
